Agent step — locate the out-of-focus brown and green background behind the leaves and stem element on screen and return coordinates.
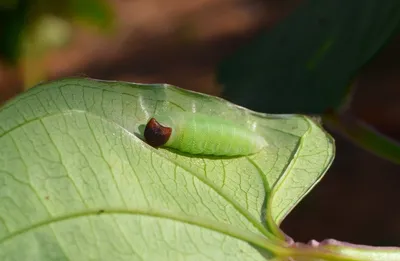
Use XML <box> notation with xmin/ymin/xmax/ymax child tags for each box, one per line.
<box><xmin>0</xmin><ymin>0</ymin><xmax>400</xmax><ymax>246</ymax></box>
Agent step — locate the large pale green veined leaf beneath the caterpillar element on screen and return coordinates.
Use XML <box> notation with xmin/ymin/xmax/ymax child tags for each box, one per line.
<box><xmin>0</xmin><ymin>79</ymin><xmax>334</xmax><ymax>261</ymax></box>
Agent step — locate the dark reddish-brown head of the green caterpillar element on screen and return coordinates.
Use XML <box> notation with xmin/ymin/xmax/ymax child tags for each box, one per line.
<box><xmin>144</xmin><ymin>118</ymin><xmax>172</xmax><ymax>148</ymax></box>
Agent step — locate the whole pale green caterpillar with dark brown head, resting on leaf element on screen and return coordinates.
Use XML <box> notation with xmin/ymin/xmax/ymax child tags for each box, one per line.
<box><xmin>144</xmin><ymin>112</ymin><xmax>267</xmax><ymax>156</ymax></box>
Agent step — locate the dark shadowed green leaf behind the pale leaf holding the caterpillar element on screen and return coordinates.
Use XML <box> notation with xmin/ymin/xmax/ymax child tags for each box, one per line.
<box><xmin>218</xmin><ymin>0</ymin><xmax>400</xmax><ymax>114</ymax></box>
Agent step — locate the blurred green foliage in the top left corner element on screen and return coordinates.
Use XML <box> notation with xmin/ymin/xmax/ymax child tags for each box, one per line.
<box><xmin>0</xmin><ymin>0</ymin><xmax>114</xmax><ymax>64</ymax></box>
